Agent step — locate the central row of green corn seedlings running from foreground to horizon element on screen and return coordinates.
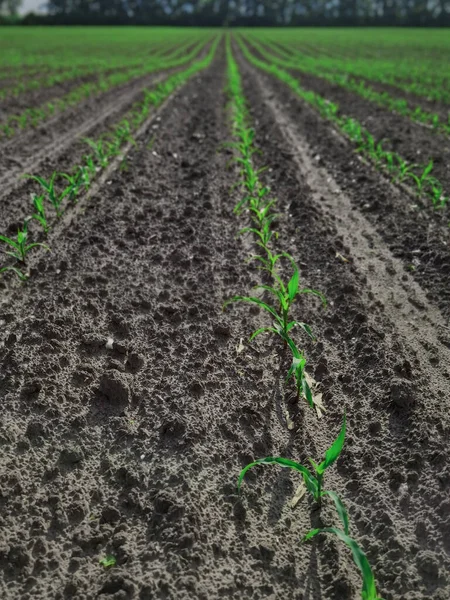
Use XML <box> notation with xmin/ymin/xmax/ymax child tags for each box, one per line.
<box><xmin>224</xmin><ymin>37</ymin><xmax>380</xmax><ymax>600</ymax></box>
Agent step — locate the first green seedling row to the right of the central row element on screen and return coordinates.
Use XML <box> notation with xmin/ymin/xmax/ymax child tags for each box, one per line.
<box><xmin>236</xmin><ymin>36</ymin><xmax>449</xmax><ymax>208</ymax></box>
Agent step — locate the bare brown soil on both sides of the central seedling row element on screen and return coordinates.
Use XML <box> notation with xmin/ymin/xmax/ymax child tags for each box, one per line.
<box><xmin>0</xmin><ymin>38</ymin><xmax>450</xmax><ymax>600</ymax></box>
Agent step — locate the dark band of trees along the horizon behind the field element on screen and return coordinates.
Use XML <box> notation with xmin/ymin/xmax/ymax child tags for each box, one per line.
<box><xmin>0</xmin><ymin>0</ymin><xmax>450</xmax><ymax>27</ymax></box>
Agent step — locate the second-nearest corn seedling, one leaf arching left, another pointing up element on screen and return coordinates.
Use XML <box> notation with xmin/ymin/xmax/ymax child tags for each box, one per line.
<box><xmin>238</xmin><ymin>413</ymin><xmax>349</xmax><ymax>524</ymax></box>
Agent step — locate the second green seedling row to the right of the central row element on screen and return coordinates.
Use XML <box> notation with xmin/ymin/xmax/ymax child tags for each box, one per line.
<box><xmin>247</xmin><ymin>38</ymin><xmax>450</xmax><ymax>135</ymax></box>
